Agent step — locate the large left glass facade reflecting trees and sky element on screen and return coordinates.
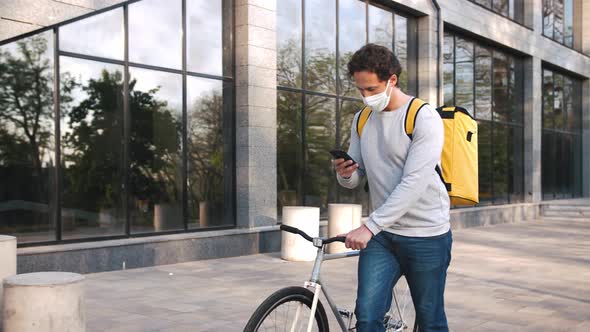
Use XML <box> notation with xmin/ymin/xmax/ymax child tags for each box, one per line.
<box><xmin>0</xmin><ymin>0</ymin><xmax>235</xmax><ymax>244</ymax></box>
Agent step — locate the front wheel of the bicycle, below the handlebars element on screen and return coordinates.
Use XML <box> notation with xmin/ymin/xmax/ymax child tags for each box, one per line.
<box><xmin>244</xmin><ymin>287</ymin><xmax>329</xmax><ymax>332</ymax></box>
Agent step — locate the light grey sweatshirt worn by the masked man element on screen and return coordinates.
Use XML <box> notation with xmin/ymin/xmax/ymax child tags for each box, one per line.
<box><xmin>337</xmin><ymin>97</ymin><xmax>450</xmax><ymax>237</ymax></box>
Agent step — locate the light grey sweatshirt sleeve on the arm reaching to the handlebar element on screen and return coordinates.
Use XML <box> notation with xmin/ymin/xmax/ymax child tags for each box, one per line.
<box><xmin>365</xmin><ymin>105</ymin><xmax>444</xmax><ymax>235</ymax></box>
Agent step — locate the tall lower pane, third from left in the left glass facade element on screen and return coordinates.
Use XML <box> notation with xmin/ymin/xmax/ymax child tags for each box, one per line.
<box><xmin>128</xmin><ymin>68</ymin><xmax>184</xmax><ymax>233</ymax></box>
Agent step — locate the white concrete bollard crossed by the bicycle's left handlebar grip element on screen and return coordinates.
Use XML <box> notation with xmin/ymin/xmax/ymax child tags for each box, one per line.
<box><xmin>281</xmin><ymin>206</ymin><xmax>320</xmax><ymax>262</ymax></box>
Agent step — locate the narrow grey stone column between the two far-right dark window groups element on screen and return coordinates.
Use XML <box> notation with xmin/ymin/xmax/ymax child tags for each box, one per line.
<box><xmin>524</xmin><ymin>57</ymin><xmax>543</xmax><ymax>203</ymax></box>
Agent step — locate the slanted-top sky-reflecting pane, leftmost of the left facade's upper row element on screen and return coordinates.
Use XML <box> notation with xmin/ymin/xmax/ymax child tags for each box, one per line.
<box><xmin>59</xmin><ymin>8</ymin><xmax>124</xmax><ymax>60</ymax></box>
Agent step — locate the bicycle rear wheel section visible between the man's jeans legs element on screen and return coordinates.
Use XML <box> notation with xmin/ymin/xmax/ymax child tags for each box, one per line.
<box><xmin>385</xmin><ymin>276</ymin><xmax>416</xmax><ymax>332</ymax></box>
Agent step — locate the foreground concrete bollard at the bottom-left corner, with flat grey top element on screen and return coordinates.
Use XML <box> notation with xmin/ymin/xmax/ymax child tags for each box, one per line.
<box><xmin>4</xmin><ymin>272</ymin><xmax>86</xmax><ymax>332</ymax></box>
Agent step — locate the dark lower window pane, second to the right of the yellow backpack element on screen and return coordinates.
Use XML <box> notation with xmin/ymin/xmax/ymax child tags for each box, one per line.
<box><xmin>492</xmin><ymin>123</ymin><xmax>512</xmax><ymax>204</ymax></box>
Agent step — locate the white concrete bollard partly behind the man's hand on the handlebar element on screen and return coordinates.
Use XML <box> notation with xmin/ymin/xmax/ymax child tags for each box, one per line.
<box><xmin>328</xmin><ymin>204</ymin><xmax>363</xmax><ymax>254</ymax></box>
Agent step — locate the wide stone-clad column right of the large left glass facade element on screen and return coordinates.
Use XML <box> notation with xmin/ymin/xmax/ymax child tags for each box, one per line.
<box><xmin>235</xmin><ymin>0</ymin><xmax>277</xmax><ymax>228</ymax></box>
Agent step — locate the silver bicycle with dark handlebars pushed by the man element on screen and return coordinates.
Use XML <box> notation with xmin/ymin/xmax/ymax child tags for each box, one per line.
<box><xmin>244</xmin><ymin>225</ymin><xmax>417</xmax><ymax>332</ymax></box>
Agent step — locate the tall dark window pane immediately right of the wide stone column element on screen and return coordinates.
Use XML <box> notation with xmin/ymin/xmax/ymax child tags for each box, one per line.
<box><xmin>277</xmin><ymin>90</ymin><xmax>303</xmax><ymax>215</ymax></box>
